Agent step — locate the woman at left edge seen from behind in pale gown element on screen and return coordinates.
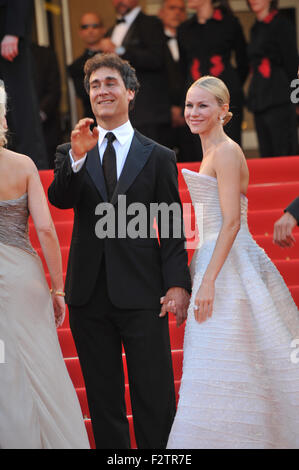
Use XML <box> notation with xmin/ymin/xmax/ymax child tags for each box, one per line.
<box><xmin>0</xmin><ymin>84</ymin><xmax>90</xmax><ymax>449</ymax></box>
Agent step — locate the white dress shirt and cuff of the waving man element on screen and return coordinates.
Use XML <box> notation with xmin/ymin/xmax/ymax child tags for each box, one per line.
<box><xmin>69</xmin><ymin>121</ymin><xmax>134</xmax><ymax>179</ymax></box>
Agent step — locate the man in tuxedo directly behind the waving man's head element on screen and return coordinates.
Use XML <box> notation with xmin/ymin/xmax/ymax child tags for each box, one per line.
<box><xmin>101</xmin><ymin>0</ymin><xmax>171</xmax><ymax>146</ymax></box>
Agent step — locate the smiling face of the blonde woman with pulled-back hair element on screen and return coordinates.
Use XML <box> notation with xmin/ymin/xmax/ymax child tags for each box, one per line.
<box><xmin>185</xmin><ymin>85</ymin><xmax>228</xmax><ymax>134</ymax></box>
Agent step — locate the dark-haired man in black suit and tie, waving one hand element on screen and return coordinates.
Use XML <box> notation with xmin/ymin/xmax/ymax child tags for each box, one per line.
<box><xmin>48</xmin><ymin>54</ymin><xmax>191</xmax><ymax>448</ymax></box>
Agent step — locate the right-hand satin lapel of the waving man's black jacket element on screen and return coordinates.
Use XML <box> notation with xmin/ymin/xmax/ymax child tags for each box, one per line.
<box><xmin>111</xmin><ymin>131</ymin><xmax>154</xmax><ymax>204</ymax></box>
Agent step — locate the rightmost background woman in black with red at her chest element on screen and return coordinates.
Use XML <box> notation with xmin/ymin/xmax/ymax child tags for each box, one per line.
<box><xmin>247</xmin><ymin>0</ymin><xmax>298</xmax><ymax>157</ymax></box>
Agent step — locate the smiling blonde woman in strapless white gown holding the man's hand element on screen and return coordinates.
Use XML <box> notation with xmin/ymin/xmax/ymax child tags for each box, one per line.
<box><xmin>168</xmin><ymin>77</ymin><xmax>299</xmax><ymax>449</ymax></box>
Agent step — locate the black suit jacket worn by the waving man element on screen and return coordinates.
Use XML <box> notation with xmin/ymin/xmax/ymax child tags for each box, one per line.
<box><xmin>48</xmin><ymin>131</ymin><xmax>191</xmax><ymax>309</ymax></box>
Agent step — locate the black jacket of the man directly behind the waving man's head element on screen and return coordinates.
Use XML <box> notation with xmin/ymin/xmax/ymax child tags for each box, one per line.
<box><xmin>107</xmin><ymin>12</ymin><xmax>170</xmax><ymax>127</ymax></box>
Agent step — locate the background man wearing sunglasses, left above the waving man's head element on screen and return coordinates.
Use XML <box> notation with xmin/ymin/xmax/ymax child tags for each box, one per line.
<box><xmin>68</xmin><ymin>12</ymin><xmax>105</xmax><ymax>119</ymax></box>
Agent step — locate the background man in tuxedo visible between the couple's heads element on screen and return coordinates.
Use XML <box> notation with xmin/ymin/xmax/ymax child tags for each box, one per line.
<box><xmin>159</xmin><ymin>0</ymin><xmax>197</xmax><ymax>162</ymax></box>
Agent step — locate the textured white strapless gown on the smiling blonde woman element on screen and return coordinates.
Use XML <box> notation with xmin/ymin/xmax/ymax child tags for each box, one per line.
<box><xmin>168</xmin><ymin>169</ymin><xmax>299</xmax><ymax>449</ymax></box>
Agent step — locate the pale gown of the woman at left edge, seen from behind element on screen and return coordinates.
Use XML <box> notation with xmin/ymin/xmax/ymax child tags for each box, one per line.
<box><xmin>0</xmin><ymin>194</ymin><xmax>90</xmax><ymax>449</ymax></box>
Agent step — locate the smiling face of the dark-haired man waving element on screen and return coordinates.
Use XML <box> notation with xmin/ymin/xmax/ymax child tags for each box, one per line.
<box><xmin>89</xmin><ymin>67</ymin><xmax>135</xmax><ymax>129</ymax></box>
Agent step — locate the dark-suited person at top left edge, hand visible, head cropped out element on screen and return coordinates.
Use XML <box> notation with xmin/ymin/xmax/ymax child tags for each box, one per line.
<box><xmin>0</xmin><ymin>0</ymin><xmax>48</xmax><ymax>169</ymax></box>
